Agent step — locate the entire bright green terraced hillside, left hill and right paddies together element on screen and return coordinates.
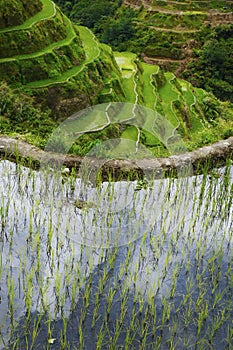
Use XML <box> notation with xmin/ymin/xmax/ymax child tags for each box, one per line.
<box><xmin>0</xmin><ymin>0</ymin><xmax>233</xmax><ymax>156</ymax></box>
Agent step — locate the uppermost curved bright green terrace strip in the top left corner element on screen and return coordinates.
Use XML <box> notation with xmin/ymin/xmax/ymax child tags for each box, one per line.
<box><xmin>0</xmin><ymin>0</ymin><xmax>56</xmax><ymax>34</ymax></box>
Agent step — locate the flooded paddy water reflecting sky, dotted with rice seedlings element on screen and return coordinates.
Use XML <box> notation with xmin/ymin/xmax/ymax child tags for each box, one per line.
<box><xmin>0</xmin><ymin>161</ymin><xmax>233</xmax><ymax>350</ymax></box>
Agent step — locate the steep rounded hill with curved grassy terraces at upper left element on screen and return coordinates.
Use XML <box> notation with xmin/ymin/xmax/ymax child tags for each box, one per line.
<box><xmin>0</xmin><ymin>0</ymin><xmax>123</xmax><ymax>117</ymax></box>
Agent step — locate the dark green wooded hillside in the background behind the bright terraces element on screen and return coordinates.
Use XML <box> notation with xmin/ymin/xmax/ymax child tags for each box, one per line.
<box><xmin>56</xmin><ymin>0</ymin><xmax>233</xmax><ymax>101</ymax></box>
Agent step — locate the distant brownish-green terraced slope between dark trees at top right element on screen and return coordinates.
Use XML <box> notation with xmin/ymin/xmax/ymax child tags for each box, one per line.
<box><xmin>123</xmin><ymin>0</ymin><xmax>233</xmax><ymax>70</ymax></box>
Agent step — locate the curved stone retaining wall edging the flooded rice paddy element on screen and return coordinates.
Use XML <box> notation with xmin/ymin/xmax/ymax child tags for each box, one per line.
<box><xmin>0</xmin><ymin>136</ymin><xmax>233</xmax><ymax>178</ymax></box>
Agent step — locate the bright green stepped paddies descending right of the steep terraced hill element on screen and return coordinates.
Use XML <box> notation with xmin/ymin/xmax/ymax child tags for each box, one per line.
<box><xmin>68</xmin><ymin>52</ymin><xmax>233</xmax><ymax>157</ymax></box>
